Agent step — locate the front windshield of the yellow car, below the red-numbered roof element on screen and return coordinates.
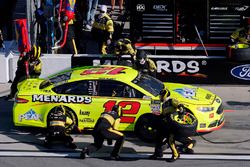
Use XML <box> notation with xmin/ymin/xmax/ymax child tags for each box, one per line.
<box><xmin>132</xmin><ymin>73</ymin><xmax>164</xmax><ymax>96</ymax></box>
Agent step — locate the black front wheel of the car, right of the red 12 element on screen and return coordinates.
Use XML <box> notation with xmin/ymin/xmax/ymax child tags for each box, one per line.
<box><xmin>135</xmin><ymin>114</ymin><xmax>157</xmax><ymax>143</ymax></box>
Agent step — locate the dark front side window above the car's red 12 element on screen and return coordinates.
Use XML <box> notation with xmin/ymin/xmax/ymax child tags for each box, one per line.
<box><xmin>98</xmin><ymin>80</ymin><xmax>143</xmax><ymax>98</ymax></box>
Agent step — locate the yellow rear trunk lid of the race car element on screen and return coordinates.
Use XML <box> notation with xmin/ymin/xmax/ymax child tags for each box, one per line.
<box><xmin>17</xmin><ymin>78</ymin><xmax>44</xmax><ymax>94</ymax></box>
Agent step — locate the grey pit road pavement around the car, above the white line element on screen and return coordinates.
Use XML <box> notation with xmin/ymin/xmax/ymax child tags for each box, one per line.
<box><xmin>0</xmin><ymin>83</ymin><xmax>250</xmax><ymax>160</ymax></box>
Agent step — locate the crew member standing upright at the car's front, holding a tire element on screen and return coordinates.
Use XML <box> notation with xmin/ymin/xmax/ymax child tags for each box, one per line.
<box><xmin>150</xmin><ymin>90</ymin><xmax>190</xmax><ymax>162</ymax></box>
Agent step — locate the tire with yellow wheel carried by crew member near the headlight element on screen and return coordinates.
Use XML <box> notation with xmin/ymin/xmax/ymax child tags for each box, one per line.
<box><xmin>168</xmin><ymin>111</ymin><xmax>198</xmax><ymax>137</ymax></box>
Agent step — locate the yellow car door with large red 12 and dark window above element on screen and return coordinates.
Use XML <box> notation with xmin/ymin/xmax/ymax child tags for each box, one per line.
<box><xmin>96</xmin><ymin>80</ymin><xmax>151</xmax><ymax>131</ymax></box>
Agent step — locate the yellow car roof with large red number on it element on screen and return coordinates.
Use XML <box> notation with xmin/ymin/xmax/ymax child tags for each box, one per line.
<box><xmin>70</xmin><ymin>65</ymin><xmax>138</xmax><ymax>82</ymax></box>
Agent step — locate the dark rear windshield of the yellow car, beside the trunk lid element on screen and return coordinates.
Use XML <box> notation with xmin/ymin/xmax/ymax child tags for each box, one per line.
<box><xmin>40</xmin><ymin>71</ymin><xmax>72</xmax><ymax>89</ymax></box>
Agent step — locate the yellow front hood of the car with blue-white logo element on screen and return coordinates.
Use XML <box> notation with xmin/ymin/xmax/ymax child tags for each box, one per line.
<box><xmin>164</xmin><ymin>83</ymin><xmax>216</xmax><ymax>105</ymax></box>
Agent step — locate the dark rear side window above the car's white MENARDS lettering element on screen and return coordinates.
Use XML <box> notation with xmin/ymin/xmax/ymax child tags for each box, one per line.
<box><xmin>53</xmin><ymin>81</ymin><xmax>96</xmax><ymax>95</ymax></box>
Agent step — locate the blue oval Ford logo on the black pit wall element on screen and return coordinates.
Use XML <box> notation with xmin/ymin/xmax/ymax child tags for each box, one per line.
<box><xmin>231</xmin><ymin>64</ymin><xmax>250</xmax><ymax>80</ymax></box>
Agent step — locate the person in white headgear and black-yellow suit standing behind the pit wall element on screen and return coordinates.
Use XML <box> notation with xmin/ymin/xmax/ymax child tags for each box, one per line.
<box><xmin>91</xmin><ymin>5</ymin><xmax>114</xmax><ymax>54</ymax></box>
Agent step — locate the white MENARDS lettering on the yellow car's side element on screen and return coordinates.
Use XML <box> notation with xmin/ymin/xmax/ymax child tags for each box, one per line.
<box><xmin>32</xmin><ymin>94</ymin><xmax>92</xmax><ymax>104</ymax></box>
